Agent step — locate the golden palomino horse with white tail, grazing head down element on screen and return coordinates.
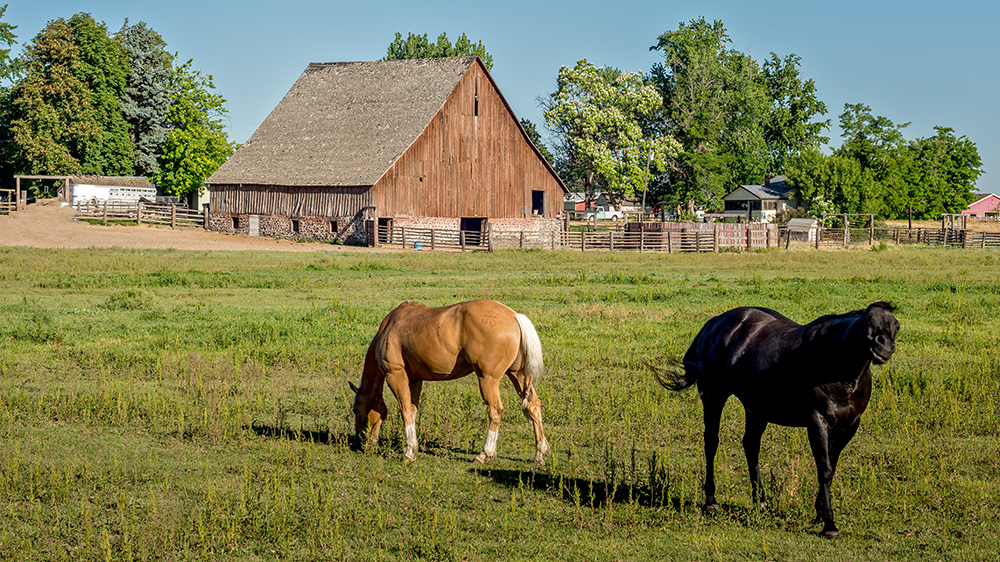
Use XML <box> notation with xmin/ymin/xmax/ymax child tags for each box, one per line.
<box><xmin>350</xmin><ymin>300</ymin><xmax>549</xmax><ymax>464</ymax></box>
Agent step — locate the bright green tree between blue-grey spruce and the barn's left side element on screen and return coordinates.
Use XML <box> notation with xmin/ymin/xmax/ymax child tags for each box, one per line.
<box><xmin>156</xmin><ymin>60</ymin><xmax>236</xmax><ymax>196</ymax></box>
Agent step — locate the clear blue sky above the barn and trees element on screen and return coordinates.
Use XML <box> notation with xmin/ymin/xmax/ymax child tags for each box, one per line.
<box><xmin>9</xmin><ymin>0</ymin><xmax>1000</xmax><ymax>194</ymax></box>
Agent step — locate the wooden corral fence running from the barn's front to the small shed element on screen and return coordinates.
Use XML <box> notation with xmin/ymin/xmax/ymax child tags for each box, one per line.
<box><xmin>378</xmin><ymin>223</ymin><xmax>780</xmax><ymax>253</ymax></box>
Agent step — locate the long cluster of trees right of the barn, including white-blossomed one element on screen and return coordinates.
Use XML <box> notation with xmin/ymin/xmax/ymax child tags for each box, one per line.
<box><xmin>539</xmin><ymin>18</ymin><xmax>983</xmax><ymax>219</ymax></box>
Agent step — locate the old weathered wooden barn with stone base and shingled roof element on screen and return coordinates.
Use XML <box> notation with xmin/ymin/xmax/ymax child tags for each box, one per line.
<box><xmin>207</xmin><ymin>57</ymin><xmax>567</xmax><ymax>244</ymax></box>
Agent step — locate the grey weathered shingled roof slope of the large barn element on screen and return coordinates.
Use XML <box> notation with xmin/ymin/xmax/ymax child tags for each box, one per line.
<box><xmin>208</xmin><ymin>57</ymin><xmax>476</xmax><ymax>186</ymax></box>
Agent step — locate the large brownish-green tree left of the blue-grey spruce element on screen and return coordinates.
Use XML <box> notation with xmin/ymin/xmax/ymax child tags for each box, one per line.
<box><xmin>10</xmin><ymin>13</ymin><xmax>134</xmax><ymax>175</ymax></box>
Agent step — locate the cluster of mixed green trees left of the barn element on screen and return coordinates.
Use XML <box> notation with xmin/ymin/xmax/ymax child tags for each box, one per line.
<box><xmin>0</xmin><ymin>5</ymin><xmax>236</xmax><ymax>196</ymax></box>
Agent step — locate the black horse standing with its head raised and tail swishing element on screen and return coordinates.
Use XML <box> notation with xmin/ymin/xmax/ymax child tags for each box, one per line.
<box><xmin>652</xmin><ymin>302</ymin><xmax>899</xmax><ymax>539</ymax></box>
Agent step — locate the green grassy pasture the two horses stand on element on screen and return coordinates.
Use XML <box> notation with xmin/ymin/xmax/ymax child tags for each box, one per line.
<box><xmin>0</xmin><ymin>247</ymin><xmax>1000</xmax><ymax>561</ymax></box>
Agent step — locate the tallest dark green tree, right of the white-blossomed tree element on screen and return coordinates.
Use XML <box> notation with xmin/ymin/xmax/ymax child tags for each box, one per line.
<box><xmin>650</xmin><ymin>17</ymin><xmax>829</xmax><ymax>212</ymax></box>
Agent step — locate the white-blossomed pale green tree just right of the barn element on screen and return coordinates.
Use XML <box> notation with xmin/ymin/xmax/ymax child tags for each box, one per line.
<box><xmin>544</xmin><ymin>59</ymin><xmax>679</xmax><ymax>206</ymax></box>
